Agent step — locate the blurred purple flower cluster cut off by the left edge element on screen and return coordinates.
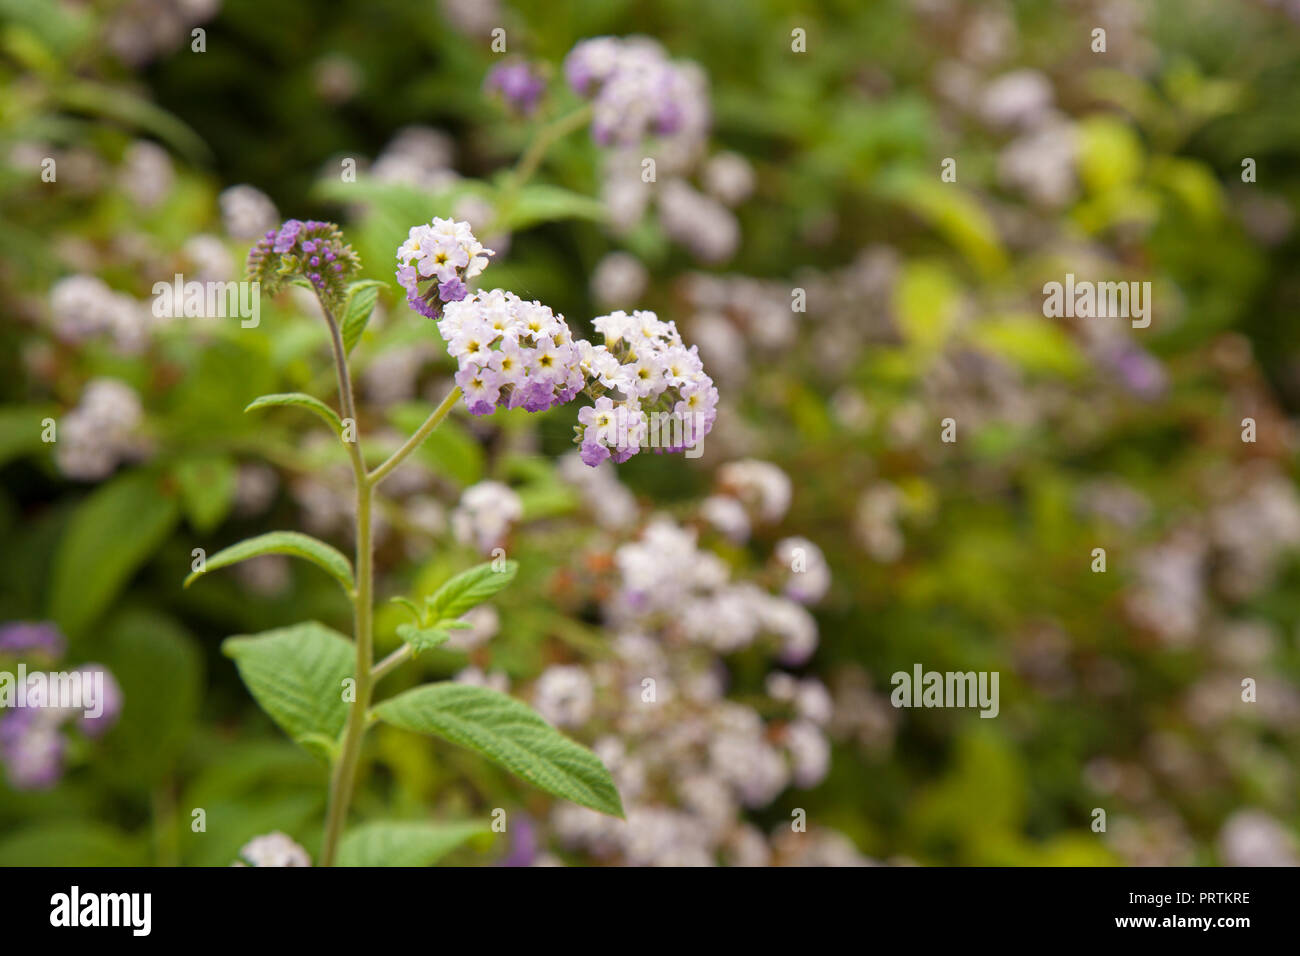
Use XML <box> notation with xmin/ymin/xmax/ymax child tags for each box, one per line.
<box><xmin>0</xmin><ymin>622</ymin><xmax>122</xmax><ymax>790</ymax></box>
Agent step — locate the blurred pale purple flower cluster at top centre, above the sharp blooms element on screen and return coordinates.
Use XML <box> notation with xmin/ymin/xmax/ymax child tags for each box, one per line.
<box><xmin>564</xmin><ymin>36</ymin><xmax>709</xmax><ymax>146</ymax></box>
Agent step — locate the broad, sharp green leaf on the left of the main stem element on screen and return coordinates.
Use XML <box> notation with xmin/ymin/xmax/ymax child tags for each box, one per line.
<box><xmin>221</xmin><ymin>620</ymin><xmax>355</xmax><ymax>754</ymax></box>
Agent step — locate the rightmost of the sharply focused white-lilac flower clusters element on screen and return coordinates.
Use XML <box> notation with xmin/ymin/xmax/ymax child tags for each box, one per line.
<box><xmin>575</xmin><ymin>311</ymin><xmax>718</xmax><ymax>466</ymax></box>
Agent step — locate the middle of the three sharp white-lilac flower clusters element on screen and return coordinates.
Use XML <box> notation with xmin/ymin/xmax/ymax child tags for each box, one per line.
<box><xmin>438</xmin><ymin>289</ymin><xmax>584</xmax><ymax>415</ymax></box>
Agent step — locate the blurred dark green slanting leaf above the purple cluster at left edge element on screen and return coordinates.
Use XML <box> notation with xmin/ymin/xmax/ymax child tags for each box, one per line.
<box><xmin>49</xmin><ymin>471</ymin><xmax>179</xmax><ymax>636</ymax></box>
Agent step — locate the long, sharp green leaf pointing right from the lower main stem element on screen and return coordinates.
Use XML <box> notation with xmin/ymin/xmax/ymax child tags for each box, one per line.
<box><xmin>374</xmin><ymin>682</ymin><xmax>623</xmax><ymax>817</ymax></box>
